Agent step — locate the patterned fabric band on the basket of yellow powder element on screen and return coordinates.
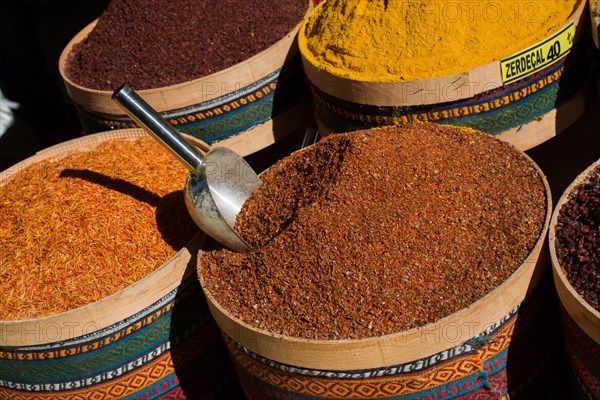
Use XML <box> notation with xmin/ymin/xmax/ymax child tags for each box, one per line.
<box><xmin>311</xmin><ymin>41</ymin><xmax>588</xmax><ymax>135</ymax></box>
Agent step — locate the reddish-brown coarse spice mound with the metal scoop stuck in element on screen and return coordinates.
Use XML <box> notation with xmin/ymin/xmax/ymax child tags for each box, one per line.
<box><xmin>198</xmin><ymin>124</ymin><xmax>547</xmax><ymax>339</ymax></box>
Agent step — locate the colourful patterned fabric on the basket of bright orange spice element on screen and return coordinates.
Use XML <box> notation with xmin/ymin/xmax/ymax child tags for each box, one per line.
<box><xmin>0</xmin><ymin>276</ymin><xmax>244</xmax><ymax>399</ymax></box>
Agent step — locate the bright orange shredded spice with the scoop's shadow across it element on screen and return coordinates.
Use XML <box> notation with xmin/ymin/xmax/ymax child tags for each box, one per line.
<box><xmin>0</xmin><ymin>137</ymin><xmax>197</xmax><ymax>320</ymax></box>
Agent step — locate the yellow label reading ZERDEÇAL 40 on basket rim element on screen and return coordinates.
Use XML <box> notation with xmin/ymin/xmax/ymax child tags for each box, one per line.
<box><xmin>500</xmin><ymin>22</ymin><xmax>575</xmax><ymax>85</ymax></box>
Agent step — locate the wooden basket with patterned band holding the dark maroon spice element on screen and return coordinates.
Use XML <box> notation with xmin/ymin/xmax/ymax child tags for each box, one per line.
<box><xmin>59</xmin><ymin>1</ymin><xmax>313</xmax><ymax>156</ymax></box>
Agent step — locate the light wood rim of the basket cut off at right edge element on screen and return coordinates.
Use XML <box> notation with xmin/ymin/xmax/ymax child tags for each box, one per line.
<box><xmin>548</xmin><ymin>159</ymin><xmax>600</xmax><ymax>345</ymax></box>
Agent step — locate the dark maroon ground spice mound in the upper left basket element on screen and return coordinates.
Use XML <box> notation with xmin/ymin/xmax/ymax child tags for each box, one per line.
<box><xmin>65</xmin><ymin>0</ymin><xmax>308</xmax><ymax>90</ymax></box>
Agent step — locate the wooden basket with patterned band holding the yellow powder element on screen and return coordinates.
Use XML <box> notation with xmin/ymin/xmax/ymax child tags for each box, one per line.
<box><xmin>299</xmin><ymin>0</ymin><xmax>590</xmax><ymax>150</ymax></box>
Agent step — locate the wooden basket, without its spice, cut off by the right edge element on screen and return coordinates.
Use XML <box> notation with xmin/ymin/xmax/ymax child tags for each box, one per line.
<box><xmin>548</xmin><ymin>160</ymin><xmax>600</xmax><ymax>399</ymax></box>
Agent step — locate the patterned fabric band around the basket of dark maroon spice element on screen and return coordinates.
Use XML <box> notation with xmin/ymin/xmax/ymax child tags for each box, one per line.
<box><xmin>78</xmin><ymin>56</ymin><xmax>308</xmax><ymax>143</ymax></box>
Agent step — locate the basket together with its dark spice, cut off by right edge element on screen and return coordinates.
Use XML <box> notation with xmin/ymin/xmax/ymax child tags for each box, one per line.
<box><xmin>549</xmin><ymin>160</ymin><xmax>600</xmax><ymax>399</ymax></box>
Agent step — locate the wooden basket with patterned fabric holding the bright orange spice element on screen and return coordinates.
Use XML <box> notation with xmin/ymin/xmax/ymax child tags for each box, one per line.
<box><xmin>0</xmin><ymin>129</ymin><xmax>240</xmax><ymax>399</ymax></box>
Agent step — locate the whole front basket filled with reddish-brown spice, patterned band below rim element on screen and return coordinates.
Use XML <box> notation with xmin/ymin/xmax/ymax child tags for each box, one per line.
<box><xmin>198</xmin><ymin>123</ymin><xmax>561</xmax><ymax>399</ymax></box>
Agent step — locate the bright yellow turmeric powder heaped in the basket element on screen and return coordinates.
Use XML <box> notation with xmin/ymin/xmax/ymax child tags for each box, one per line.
<box><xmin>299</xmin><ymin>0</ymin><xmax>582</xmax><ymax>82</ymax></box>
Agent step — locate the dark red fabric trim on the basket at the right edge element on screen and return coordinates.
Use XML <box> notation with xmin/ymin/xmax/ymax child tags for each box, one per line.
<box><xmin>561</xmin><ymin>306</ymin><xmax>600</xmax><ymax>399</ymax></box>
